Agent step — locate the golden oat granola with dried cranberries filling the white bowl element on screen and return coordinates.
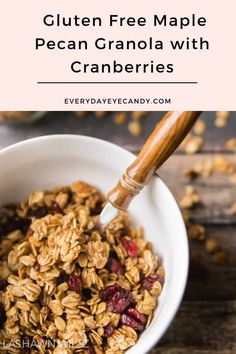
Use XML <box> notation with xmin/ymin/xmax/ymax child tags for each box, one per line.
<box><xmin>0</xmin><ymin>182</ymin><xmax>164</xmax><ymax>354</ymax></box>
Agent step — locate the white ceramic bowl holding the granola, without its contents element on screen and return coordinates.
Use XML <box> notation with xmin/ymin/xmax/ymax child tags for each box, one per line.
<box><xmin>0</xmin><ymin>135</ymin><xmax>188</xmax><ymax>354</ymax></box>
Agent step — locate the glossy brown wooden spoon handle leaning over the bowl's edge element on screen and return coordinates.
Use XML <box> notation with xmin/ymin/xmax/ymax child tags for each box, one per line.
<box><xmin>107</xmin><ymin>112</ymin><xmax>201</xmax><ymax>209</ymax></box>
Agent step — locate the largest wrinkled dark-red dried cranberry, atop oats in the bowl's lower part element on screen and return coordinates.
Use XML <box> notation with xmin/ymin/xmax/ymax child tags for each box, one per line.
<box><xmin>107</xmin><ymin>288</ymin><xmax>132</xmax><ymax>313</ymax></box>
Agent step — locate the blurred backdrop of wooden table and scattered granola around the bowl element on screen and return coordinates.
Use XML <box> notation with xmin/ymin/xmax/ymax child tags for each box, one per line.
<box><xmin>0</xmin><ymin>112</ymin><xmax>236</xmax><ymax>354</ymax></box>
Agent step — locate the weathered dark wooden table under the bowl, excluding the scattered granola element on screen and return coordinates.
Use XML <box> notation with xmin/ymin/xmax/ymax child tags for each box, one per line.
<box><xmin>0</xmin><ymin>112</ymin><xmax>236</xmax><ymax>354</ymax></box>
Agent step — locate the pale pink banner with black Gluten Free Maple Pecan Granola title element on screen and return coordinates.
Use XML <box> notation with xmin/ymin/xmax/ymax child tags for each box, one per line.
<box><xmin>0</xmin><ymin>0</ymin><xmax>236</xmax><ymax>111</ymax></box>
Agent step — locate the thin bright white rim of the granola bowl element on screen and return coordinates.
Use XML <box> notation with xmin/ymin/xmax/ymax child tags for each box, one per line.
<box><xmin>0</xmin><ymin>134</ymin><xmax>189</xmax><ymax>354</ymax></box>
